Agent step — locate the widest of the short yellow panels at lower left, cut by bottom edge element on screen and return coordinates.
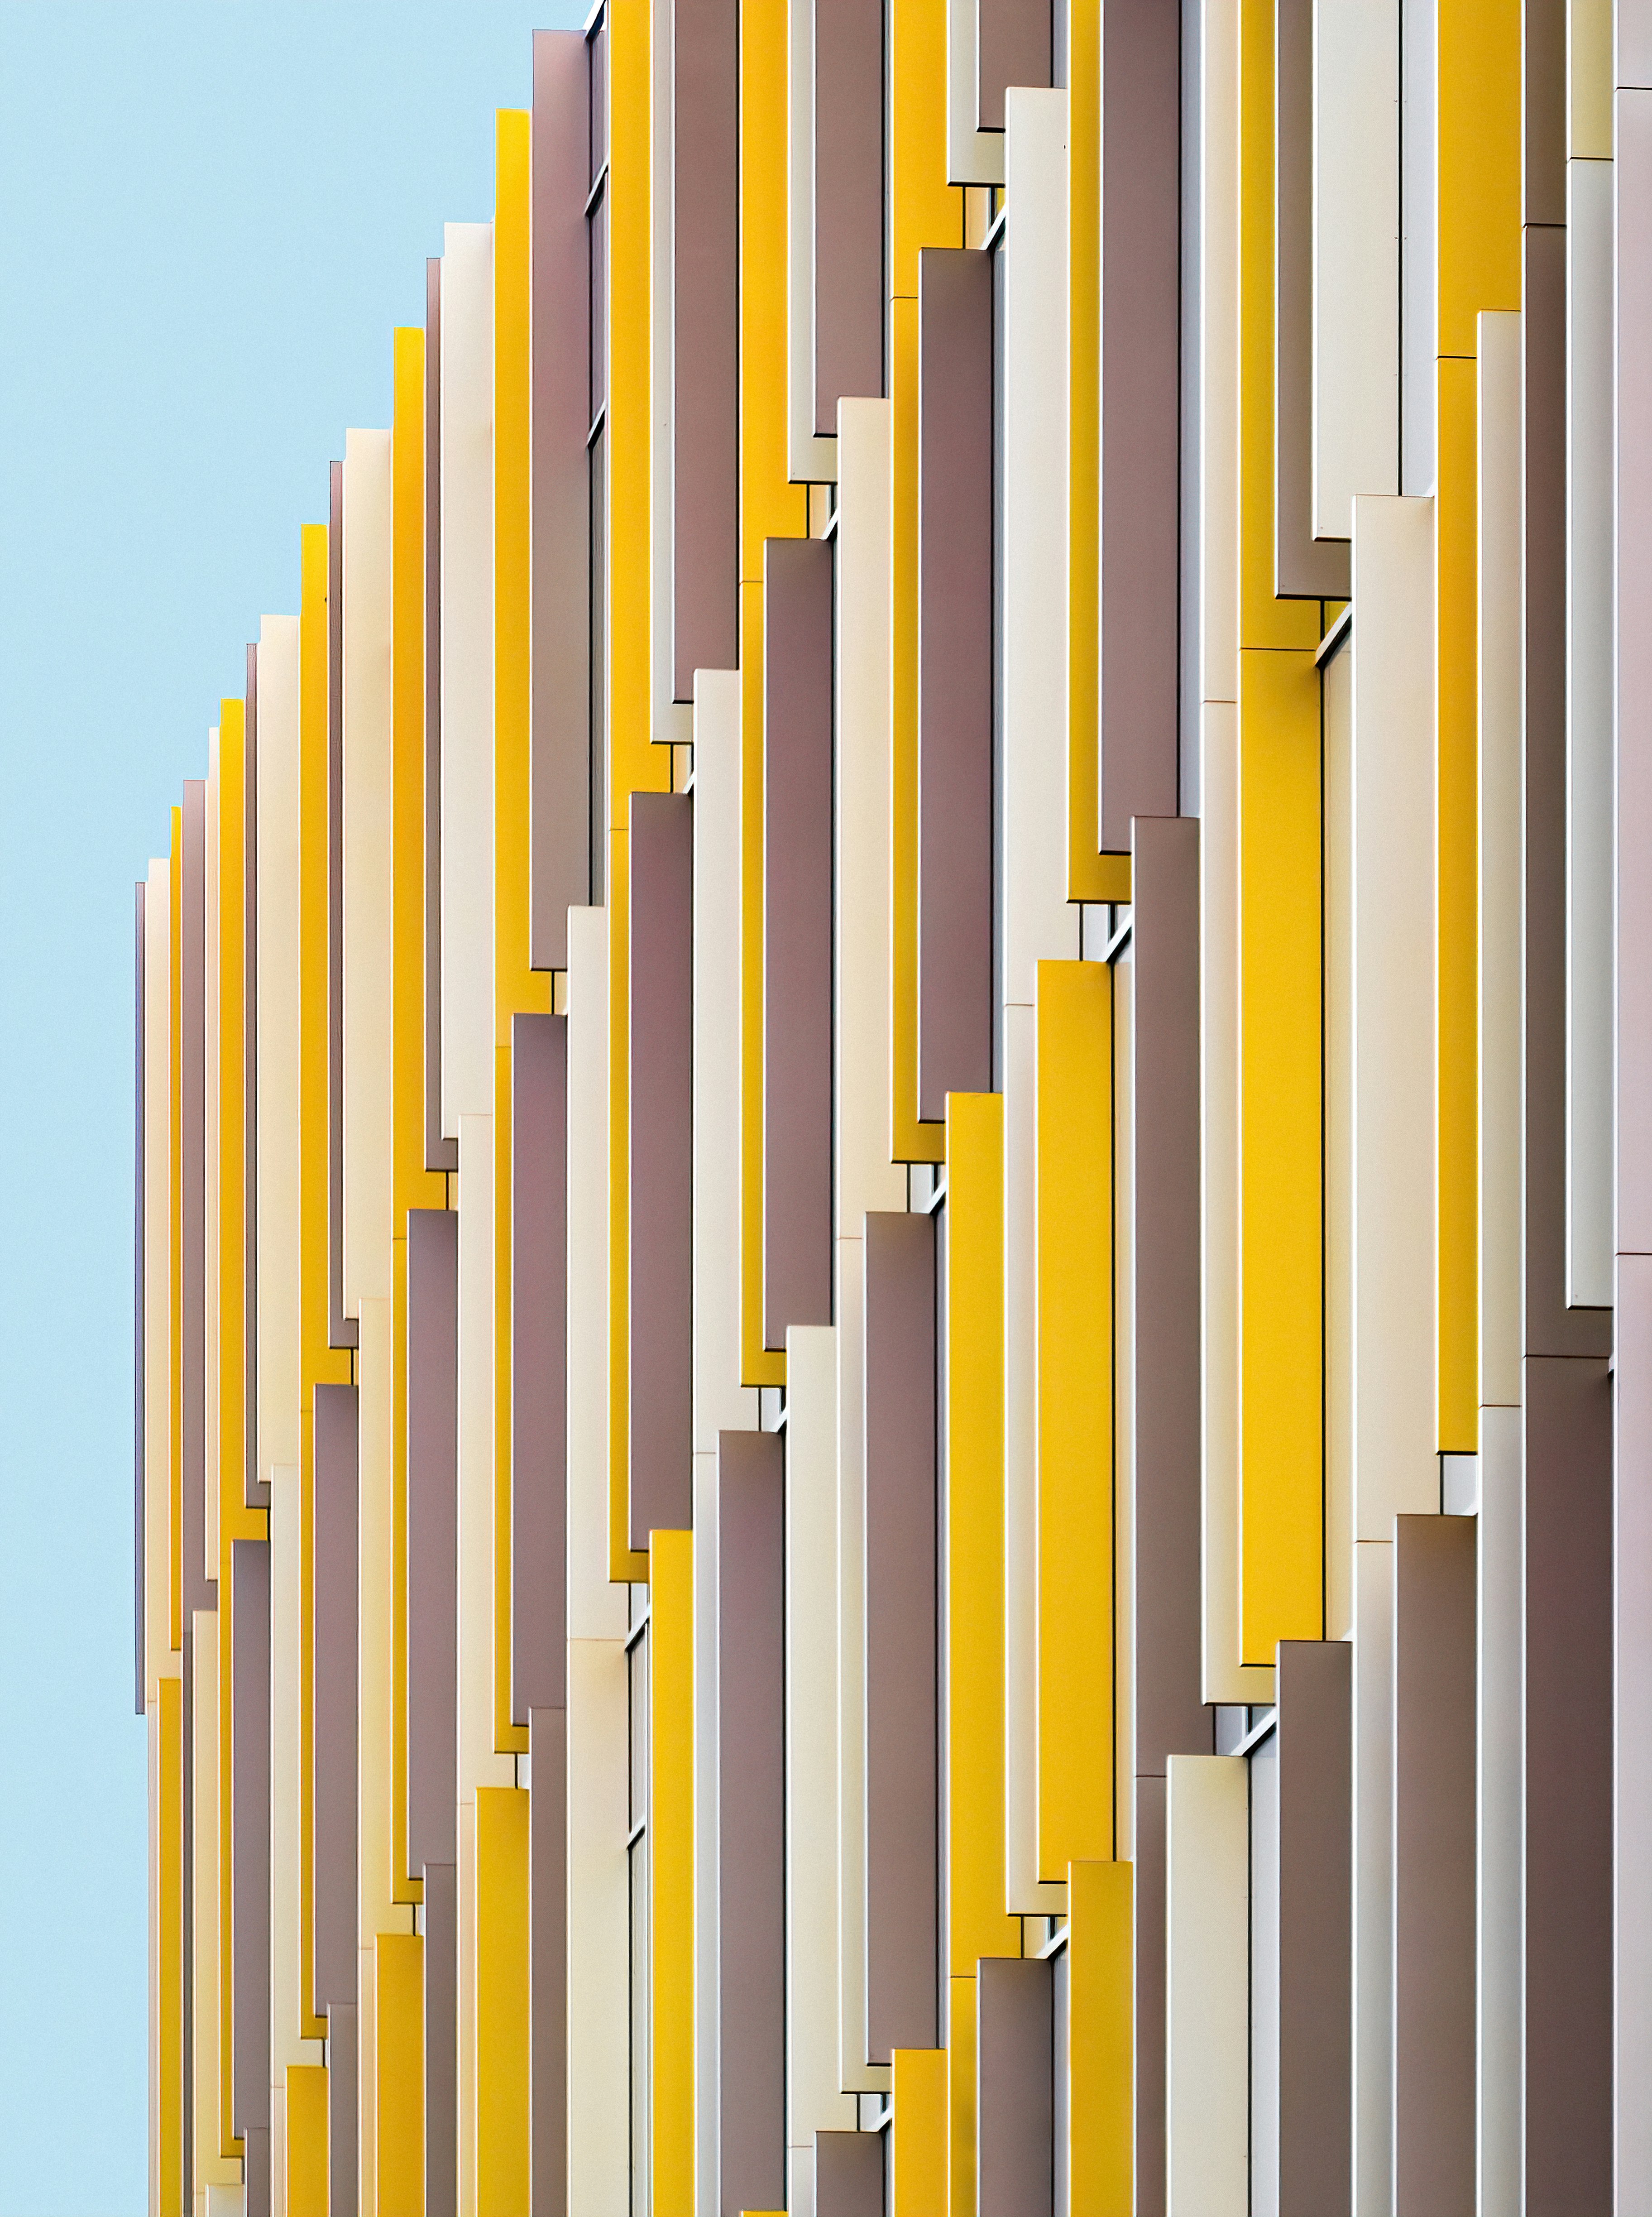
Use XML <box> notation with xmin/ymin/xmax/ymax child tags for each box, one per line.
<box><xmin>477</xmin><ymin>1787</ymin><xmax>530</xmax><ymax>2217</ymax></box>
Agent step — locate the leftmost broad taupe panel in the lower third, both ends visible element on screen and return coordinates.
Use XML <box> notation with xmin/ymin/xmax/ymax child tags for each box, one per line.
<box><xmin>230</xmin><ymin>1539</ymin><xmax>271</xmax><ymax>2133</ymax></box>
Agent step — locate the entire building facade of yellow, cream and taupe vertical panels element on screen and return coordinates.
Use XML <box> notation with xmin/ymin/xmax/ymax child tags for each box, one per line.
<box><xmin>135</xmin><ymin>13</ymin><xmax>1652</xmax><ymax>2217</ymax></box>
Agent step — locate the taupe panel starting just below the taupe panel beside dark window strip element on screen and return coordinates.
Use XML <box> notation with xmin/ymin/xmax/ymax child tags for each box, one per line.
<box><xmin>510</xmin><ymin>1015</ymin><xmax>568</xmax><ymax>1725</ymax></box>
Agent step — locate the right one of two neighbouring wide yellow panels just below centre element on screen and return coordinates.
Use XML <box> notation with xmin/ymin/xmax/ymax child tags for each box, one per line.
<box><xmin>1035</xmin><ymin>962</ymin><xmax>1113</xmax><ymax>1880</ymax></box>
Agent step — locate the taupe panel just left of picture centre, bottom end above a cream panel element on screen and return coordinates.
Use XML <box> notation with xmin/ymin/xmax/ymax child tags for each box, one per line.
<box><xmin>763</xmin><ymin>539</ymin><xmax>832</xmax><ymax>1348</ymax></box>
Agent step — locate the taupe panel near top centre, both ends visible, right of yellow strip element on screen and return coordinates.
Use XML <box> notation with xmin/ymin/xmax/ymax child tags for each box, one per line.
<box><xmin>918</xmin><ymin>246</ymin><xmax>993</xmax><ymax>1122</ymax></box>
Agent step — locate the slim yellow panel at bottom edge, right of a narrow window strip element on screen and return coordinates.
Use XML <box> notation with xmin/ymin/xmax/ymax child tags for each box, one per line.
<box><xmin>647</xmin><ymin>1532</ymin><xmax>694</xmax><ymax>2217</ymax></box>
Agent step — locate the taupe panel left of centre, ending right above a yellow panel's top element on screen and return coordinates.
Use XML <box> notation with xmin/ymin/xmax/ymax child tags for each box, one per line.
<box><xmin>630</xmin><ymin>794</ymin><xmax>694</xmax><ymax>1550</ymax></box>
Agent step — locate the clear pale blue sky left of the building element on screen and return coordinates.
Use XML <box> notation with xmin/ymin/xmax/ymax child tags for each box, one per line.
<box><xmin>0</xmin><ymin>0</ymin><xmax>583</xmax><ymax>2217</ymax></box>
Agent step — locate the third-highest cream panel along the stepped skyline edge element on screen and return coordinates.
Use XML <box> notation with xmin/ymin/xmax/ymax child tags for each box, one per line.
<box><xmin>257</xmin><ymin>616</ymin><xmax>304</xmax><ymax>1479</ymax></box>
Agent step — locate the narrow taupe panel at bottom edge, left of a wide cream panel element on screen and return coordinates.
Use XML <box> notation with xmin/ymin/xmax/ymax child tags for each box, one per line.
<box><xmin>539</xmin><ymin>1707</ymin><xmax>568</xmax><ymax>2217</ymax></box>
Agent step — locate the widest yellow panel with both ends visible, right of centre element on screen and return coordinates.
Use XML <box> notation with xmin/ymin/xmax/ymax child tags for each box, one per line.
<box><xmin>1240</xmin><ymin>652</ymin><xmax>1324</xmax><ymax>1665</ymax></box>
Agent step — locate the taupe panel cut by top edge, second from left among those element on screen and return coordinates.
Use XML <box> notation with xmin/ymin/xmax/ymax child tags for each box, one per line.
<box><xmin>812</xmin><ymin>0</ymin><xmax>885</xmax><ymax>439</ymax></box>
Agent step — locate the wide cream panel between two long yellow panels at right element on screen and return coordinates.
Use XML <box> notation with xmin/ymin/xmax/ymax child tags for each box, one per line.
<box><xmin>1348</xmin><ymin>497</ymin><xmax>1439</xmax><ymax>1541</ymax></box>
